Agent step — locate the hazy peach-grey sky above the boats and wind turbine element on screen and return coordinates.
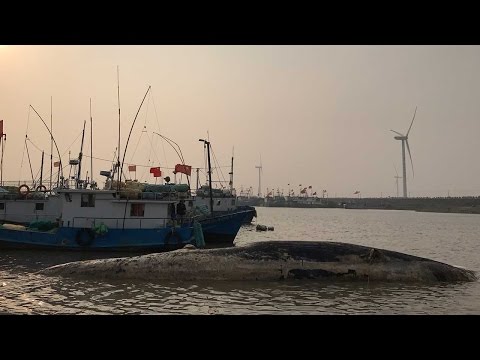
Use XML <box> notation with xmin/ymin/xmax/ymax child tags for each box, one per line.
<box><xmin>0</xmin><ymin>45</ymin><xmax>480</xmax><ymax>197</ymax></box>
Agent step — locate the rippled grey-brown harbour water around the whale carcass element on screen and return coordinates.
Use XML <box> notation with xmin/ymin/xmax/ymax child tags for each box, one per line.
<box><xmin>0</xmin><ymin>208</ymin><xmax>480</xmax><ymax>314</ymax></box>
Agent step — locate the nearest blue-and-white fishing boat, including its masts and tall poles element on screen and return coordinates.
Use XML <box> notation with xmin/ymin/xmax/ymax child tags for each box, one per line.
<box><xmin>0</xmin><ymin>83</ymin><xmax>204</xmax><ymax>251</ymax></box>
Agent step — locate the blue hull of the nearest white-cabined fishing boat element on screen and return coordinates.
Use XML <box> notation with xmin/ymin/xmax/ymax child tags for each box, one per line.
<box><xmin>0</xmin><ymin>226</ymin><xmax>195</xmax><ymax>251</ymax></box>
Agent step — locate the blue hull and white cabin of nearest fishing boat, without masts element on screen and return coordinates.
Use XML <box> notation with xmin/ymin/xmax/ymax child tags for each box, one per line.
<box><xmin>0</xmin><ymin>189</ymin><xmax>203</xmax><ymax>251</ymax></box>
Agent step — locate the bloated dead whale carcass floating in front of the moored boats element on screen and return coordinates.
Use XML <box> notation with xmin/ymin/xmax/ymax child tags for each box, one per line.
<box><xmin>41</xmin><ymin>241</ymin><xmax>476</xmax><ymax>282</ymax></box>
